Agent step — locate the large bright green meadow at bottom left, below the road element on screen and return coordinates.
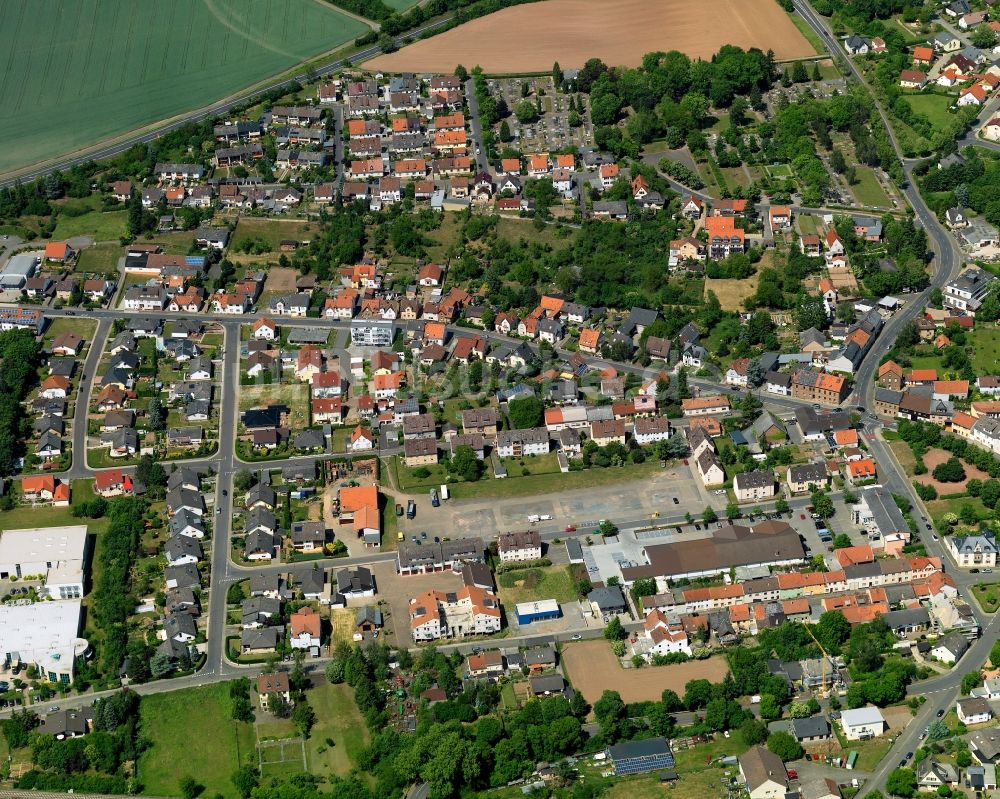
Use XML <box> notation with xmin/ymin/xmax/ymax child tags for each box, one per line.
<box><xmin>138</xmin><ymin>683</ymin><xmax>256</xmax><ymax>799</ymax></box>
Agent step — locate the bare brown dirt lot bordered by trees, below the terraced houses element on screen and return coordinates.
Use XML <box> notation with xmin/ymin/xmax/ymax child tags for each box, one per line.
<box><xmin>562</xmin><ymin>640</ymin><xmax>729</xmax><ymax>704</ymax></box>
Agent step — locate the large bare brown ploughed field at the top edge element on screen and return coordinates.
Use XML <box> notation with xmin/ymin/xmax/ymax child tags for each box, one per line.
<box><xmin>365</xmin><ymin>0</ymin><xmax>815</xmax><ymax>74</ymax></box>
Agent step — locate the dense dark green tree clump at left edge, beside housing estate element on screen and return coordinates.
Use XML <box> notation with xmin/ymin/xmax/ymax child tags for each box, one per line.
<box><xmin>0</xmin><ymin>330</ymin><xmax>41</xmax><ymax>477</ymax></box>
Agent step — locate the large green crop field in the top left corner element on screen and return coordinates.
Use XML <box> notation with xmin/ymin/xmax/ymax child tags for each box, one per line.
<box><xmin>0</xmin><ymin>0</ymin><xmax>367</xmax><ymax>172</ymax></box>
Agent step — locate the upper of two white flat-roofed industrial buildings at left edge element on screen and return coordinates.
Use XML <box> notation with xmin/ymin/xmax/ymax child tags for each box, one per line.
<box><xmin>0</xmin><ymin>524</ymin><xmax>87</xmax><ymax>599</ymax></box>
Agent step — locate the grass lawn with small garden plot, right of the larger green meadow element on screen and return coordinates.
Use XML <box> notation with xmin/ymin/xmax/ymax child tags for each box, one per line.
<box><xmin>306</xmin><ymin>681</ymin><xmax>368</xmax><ymax>775</ymax></box>
